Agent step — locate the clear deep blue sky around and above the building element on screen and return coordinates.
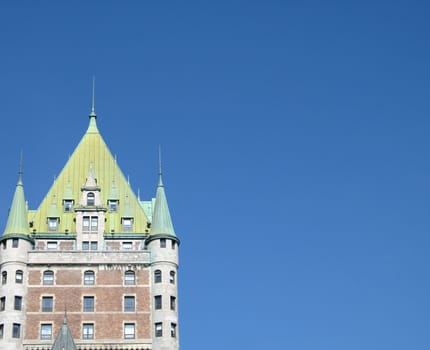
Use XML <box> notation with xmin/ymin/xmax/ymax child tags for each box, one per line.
<box><xmin>0</xmin><ymin>0</ymin><xmax>430</xmax><ymax>350</ymax></box>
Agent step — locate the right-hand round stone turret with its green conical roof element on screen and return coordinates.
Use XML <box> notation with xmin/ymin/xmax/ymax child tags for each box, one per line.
<box><xmin>146</xmin><ymin>167</ymin><xmax>179</xmax><ymax>350</ymax></box>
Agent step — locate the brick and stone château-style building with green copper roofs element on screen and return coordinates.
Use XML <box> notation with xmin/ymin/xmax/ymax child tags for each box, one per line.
<box><xmin>0</xmin><ymin>99</ymin><xmax>179</xmax><ymax>350</ymax></box>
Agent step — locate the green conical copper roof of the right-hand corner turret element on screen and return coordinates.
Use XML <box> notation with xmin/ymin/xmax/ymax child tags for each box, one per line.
<box><xmin>150</xmin><ymin>173</ymin><xmax>176</xmax><ymax>237</ymax></box>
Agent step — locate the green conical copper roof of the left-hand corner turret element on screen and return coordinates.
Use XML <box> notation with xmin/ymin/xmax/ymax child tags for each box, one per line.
<box><xmin>3</xmin><ymin>171</ymin><xmax>30</xmax><ymax>236</ymax></box>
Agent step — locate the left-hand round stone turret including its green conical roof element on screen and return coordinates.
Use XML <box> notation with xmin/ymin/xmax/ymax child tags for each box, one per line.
<box><xmin>0</xmin><ymin>170</ymin><xmax>33</xmax><ymax>350</ymax></box>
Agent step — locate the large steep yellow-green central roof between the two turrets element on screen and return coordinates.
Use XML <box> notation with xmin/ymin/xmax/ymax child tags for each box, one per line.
<box><xmin>30</xmin><ymin>112</ymin><xmax>149</xmax><ymax>233</ymax></box>
